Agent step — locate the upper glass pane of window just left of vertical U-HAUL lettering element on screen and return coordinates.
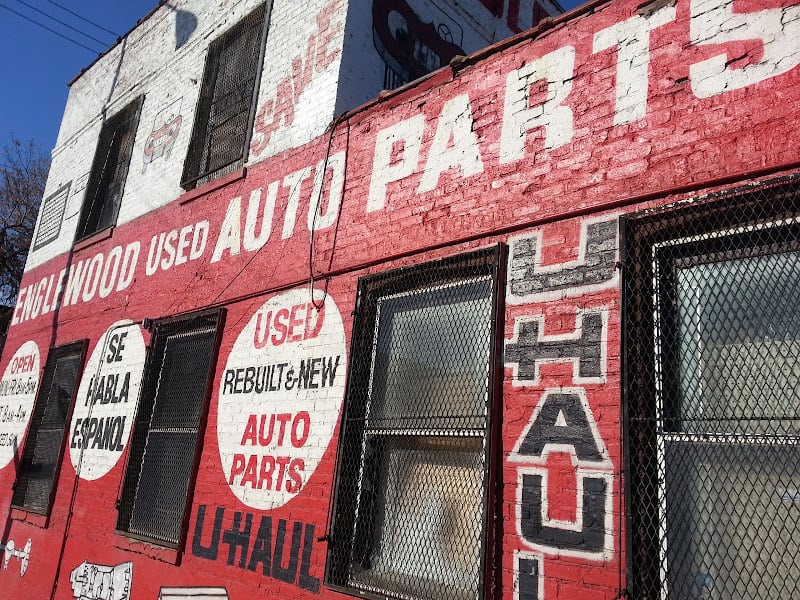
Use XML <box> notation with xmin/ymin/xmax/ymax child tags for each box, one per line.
<box><xmin>369</xmin><ymin>278</ymin><xmax>492</xmax><ymax>429</ymax></box>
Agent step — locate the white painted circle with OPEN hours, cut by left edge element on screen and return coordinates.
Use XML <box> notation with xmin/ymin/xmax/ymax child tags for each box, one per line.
<box><xmin>0</xmin><ymin>341</ymin><xmax>39</xmax><ymax>469</ymax></box>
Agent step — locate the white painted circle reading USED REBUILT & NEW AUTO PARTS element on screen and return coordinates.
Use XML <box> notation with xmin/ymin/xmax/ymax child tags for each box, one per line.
<box><xmin>217</xmin><ymin>290</ymin><xmax>347</xmax><ymax>510</ymax></box>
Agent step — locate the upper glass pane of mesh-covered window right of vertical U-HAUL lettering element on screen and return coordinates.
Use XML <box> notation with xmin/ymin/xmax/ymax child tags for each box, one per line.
<box><xmin>676</xmin><ymin>252</ymin><xmax>800</xmax><ymax>435</ymax></box>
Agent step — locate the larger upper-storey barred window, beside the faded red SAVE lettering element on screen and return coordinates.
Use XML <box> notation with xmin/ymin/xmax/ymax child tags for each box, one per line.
<box><xmin>181</xmin><ymin>5</ymin><xmax>266</xmax><ymax>189</ymax></box>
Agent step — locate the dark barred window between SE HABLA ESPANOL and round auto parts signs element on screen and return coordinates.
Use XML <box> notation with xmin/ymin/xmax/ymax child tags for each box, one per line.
<box><xmin>117</xmin><ymin>310</ymin><xmax>222</xmax><ymax>548</ymax></box>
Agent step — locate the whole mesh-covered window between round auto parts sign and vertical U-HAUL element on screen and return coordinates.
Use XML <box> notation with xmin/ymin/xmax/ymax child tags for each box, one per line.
<box><xmin>327</xmin><ymin>248</ymin><xmax>500</xmax><ymax>600</ymax></box>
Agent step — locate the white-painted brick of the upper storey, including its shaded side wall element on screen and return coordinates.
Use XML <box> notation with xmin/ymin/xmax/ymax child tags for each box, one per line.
<box><xmin>26</xmin><ymin>0</ymin><xmax>548</xmax><ymax>269</ymax></box>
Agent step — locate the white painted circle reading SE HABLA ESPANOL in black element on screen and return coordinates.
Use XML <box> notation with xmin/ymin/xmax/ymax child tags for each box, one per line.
<box><xmin>69</xmin><ymin>321</ymin><xmax>145</xmax><ymax>480</ymax></box>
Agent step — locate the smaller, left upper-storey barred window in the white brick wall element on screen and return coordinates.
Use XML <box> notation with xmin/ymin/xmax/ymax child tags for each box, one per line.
<box><xmin>75</xmin><ymin>96</ymin><xmax>144</xmax><ymax>240</ymax></box>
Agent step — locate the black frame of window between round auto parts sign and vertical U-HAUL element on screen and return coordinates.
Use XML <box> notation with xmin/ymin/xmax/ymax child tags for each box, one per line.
<box><xmin>325</xmin><ymin>244</ymin><xmax>507</xmax><ymax>600</ymax></box>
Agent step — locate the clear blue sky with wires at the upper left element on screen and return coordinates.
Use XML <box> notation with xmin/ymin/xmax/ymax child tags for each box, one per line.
<box><xmin>0</xmin><ymin>0</ymin><xmax>158</xmax><ymax>154</ymax></box>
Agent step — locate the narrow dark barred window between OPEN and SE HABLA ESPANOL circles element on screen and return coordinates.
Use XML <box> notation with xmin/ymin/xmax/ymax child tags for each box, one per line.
<box><xmin>11</xmin><ymin>340</ymin><xmax>88</xmax><ymax>517</ymax></box>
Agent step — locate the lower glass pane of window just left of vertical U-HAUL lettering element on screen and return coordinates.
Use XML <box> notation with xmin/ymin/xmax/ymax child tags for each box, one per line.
<box><xmin>353</xmin><ymin>437</ymin><xmax>483</xmax><ymax>599</ymax></box>
